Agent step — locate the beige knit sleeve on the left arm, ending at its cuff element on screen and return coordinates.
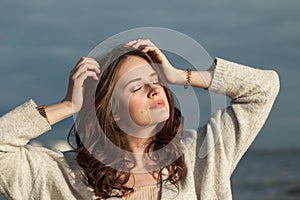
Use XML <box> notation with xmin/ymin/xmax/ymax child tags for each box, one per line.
<box><xmin>0</xmin><ymin>100</ymin><xmax>51</xmax><ymax>152</ymax></box>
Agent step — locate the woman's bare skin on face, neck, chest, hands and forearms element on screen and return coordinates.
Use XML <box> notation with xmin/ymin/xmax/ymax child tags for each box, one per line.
<box><xmin>45</xmin><ymin>40</ymin><xmax>212</xmax><ymax>187</ymax></box>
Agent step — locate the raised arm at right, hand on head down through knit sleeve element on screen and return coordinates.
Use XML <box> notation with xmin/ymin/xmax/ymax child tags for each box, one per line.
<box><xmin>128</xmin><ymin>40</ymin><xmax>279</xmax><ymax>172</ymax></box>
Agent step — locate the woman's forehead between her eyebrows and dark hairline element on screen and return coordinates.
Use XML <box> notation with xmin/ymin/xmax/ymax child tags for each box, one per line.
<box><xmin>117</xmin><ymin>56</ymin><xmax>155</xmax><ymax>80</ymax></box>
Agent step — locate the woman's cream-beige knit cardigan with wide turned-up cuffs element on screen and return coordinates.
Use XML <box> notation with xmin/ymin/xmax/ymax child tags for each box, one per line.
<box><xmin>0</xmin><ymin>58</ymin><xmax>279</xmax><ymax>200</ymax></box>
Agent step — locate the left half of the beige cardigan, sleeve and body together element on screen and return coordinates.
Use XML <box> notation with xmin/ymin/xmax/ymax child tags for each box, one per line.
<box><xmin>0</xmin><ymin>100</ymin><xmax>93</xmax><ymax>200</ymax></box>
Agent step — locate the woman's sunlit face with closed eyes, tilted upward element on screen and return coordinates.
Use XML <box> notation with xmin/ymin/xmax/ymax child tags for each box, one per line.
<box><xmin>112</xmin><ymin>56</ymin><xmax>170</xmax><ymax>132</ymax></box>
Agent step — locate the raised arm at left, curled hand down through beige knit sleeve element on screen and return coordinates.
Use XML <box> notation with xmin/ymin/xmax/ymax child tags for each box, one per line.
<box><xmin>0</xmin><ymin>58</ymin><xmax>100</xmax><ymax>152</ymax></box>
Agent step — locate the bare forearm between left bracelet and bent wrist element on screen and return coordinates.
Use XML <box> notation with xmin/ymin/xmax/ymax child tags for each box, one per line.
<box><xmin>45</xmin><ymin>101</ymin><xmax>73</xmax><ymax>125</ymax></box>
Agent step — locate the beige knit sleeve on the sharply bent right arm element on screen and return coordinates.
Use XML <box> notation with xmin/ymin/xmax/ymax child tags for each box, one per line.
<box><xmin>197</xmin><ymin>58</ymin><xmax>279</xmax><ymax>174</ymax></box>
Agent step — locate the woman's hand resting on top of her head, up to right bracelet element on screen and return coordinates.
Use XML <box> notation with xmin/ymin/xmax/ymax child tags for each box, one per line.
<box><xmin>127</xmin><ymin>39</ymin><xmax>185</xmax><ymax>84</ymax></box>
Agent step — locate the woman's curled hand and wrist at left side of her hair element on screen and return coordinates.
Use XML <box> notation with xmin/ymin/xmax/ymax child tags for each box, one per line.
<box><xmin>62</xmin><ymin>57</ymin><xmax>100</xmax><ymax>114</ymax></box>
